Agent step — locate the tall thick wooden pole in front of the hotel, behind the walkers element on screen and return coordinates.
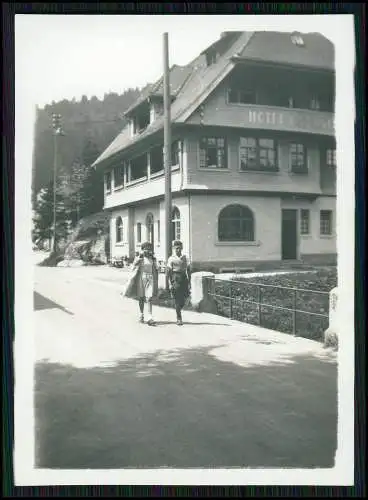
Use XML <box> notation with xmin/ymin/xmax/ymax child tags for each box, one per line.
<box><xmin>163</xmin><ymin>33</ymin><xmax>172</xmax><ymax>280</ymax></box>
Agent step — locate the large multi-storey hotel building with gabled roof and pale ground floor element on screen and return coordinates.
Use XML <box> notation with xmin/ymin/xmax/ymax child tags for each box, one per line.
<box><xmin>95</xmin><ymin>32</ymin><xmax>336</xmax><ymax>269</ymax></box>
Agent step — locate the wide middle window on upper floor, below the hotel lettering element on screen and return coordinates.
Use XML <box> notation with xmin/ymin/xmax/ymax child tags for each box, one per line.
<box><xmin>239</xmin><ymin>137</ymin><xmax>278</xmax><ymax>172</ymax></box>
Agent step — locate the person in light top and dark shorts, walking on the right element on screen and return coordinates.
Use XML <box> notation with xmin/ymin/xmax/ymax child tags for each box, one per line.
<box><xmin>167</xmin><ymin>240</ymin><xmax>190</xmax><ymax>326</ymax></box>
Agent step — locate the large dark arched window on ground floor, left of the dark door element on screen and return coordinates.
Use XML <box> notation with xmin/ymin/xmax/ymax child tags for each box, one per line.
<box><xmin>218</xmin><ymin>205</ymin><xmax>254</xmax><ymax>241</ymax></box>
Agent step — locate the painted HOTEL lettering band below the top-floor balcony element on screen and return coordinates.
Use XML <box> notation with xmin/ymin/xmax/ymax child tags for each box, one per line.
<box><xmin>245</xmin><ymin>109</ymin><xmax>334</xmax><ymax>135</ymax></box>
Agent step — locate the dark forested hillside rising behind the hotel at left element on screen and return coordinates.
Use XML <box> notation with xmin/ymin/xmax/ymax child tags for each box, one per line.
<box><xmin>32</xmin><ymin>89</ymin><xmax>141</xmax><ymax>206</ymax></box>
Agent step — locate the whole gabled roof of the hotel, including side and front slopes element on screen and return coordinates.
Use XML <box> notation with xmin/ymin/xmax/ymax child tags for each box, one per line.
<box><xmin>94</xmin><ymin>31</ymin><xmax>334</xmax><ymax>166</ymax></box>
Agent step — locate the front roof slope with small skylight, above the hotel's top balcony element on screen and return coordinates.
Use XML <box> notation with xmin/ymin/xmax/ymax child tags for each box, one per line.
<box><xmin>234</xmin><ymin>31</ymin><xmax>335</xmax><ymax>70</ymax></box>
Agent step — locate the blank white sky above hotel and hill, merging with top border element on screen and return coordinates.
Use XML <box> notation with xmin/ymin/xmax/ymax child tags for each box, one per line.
<box><xmin>15</xmin><ymin>14</ymin><xmax>346</xmax><ymax>107</ymax></box>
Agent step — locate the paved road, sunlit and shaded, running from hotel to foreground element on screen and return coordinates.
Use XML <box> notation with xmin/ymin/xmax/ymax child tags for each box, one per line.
<box><xmin>35</xmin><ymin>267</ymin><xmax>337</xmax><ymax>469</ymax></box>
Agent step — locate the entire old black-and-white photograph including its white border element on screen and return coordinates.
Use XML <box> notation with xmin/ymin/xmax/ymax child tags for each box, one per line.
<box><xmin>15</xmin><ymin>15</ymin><xmax>354</xmax><ymax>485</ymax></box>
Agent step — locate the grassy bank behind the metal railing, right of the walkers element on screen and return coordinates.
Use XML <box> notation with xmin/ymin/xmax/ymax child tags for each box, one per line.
<box><xmin>212</xmin><ymin>268</ymin><xmax>337</xmax><ymax>341</ymax></box>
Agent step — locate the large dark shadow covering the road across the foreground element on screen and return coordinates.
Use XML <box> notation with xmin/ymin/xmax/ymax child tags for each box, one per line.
<box><xmin>35</xmin><ymin>346</ymin><xmax>337</xmax><ymax>469</ymax></box>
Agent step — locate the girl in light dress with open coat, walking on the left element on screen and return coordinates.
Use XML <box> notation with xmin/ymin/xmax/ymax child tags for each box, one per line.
<box><xmin>133</xmin><ymin>241</ymin><xmax>158</xmax><ymax>326</ymax></box>
